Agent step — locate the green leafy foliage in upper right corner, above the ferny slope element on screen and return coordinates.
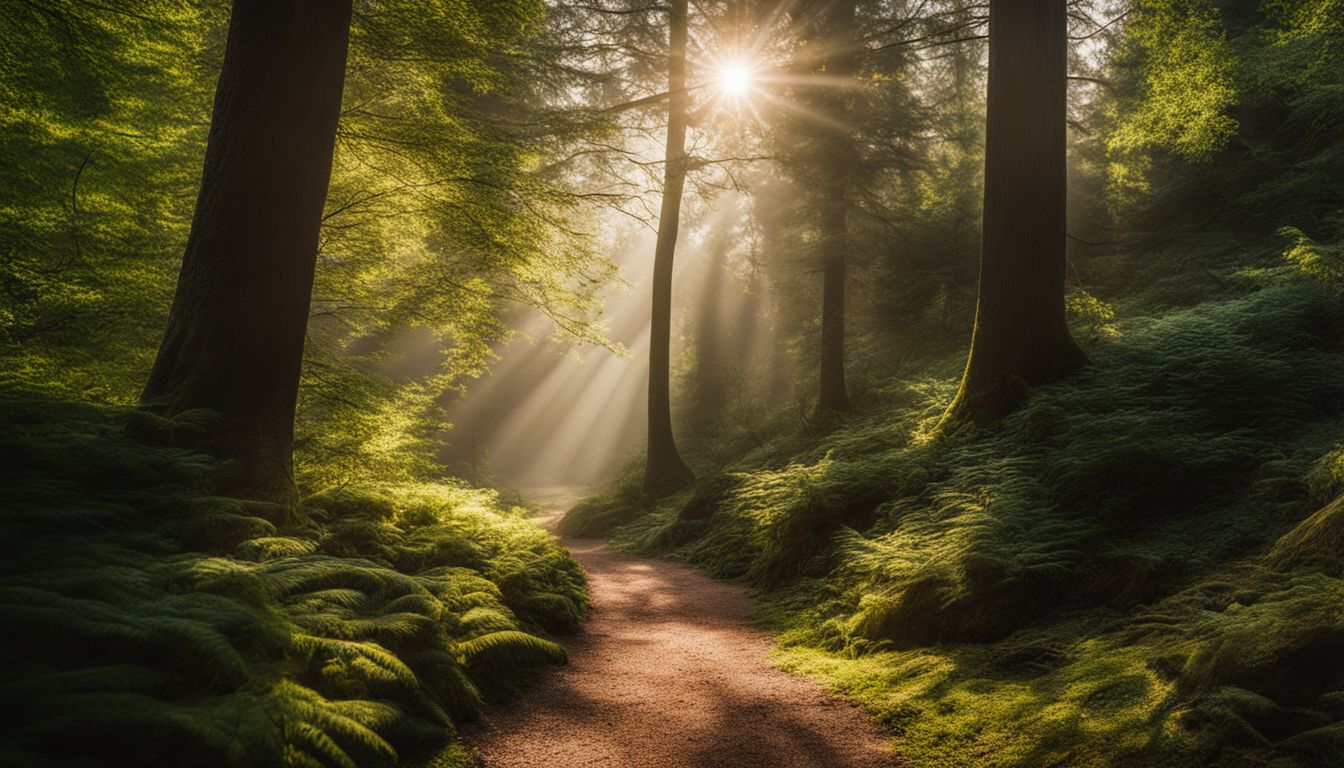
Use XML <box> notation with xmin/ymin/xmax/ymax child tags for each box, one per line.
<box><xmin>1099</xmin><ymin>0</ymin><xmax>1344</xmax><ymax>267</ymax></box>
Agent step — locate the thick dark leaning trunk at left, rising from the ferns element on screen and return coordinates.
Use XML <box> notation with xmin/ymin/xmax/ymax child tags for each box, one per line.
<box><xmin>140</xmin><ymin>0</ymin><xmax>351</xmax><ymax>502</ymax></box>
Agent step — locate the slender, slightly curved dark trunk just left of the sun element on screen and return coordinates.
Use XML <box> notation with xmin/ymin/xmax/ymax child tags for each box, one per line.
<box><xmin>644</xmin><ymin>0</ymin><xmax>692</xmax><ymax>496</ymax></box>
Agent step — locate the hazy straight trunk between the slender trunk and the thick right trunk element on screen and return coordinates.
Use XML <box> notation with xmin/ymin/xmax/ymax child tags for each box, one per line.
<box><xmin>816</xmin><ymin>0</ymin><xmax>857</xmax><ymax>410</ymax></box>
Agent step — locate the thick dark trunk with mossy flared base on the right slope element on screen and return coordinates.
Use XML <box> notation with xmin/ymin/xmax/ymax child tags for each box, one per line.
<box><xmin>942</xmin><ymin>0</ymin><xmax>1086</xmax><ymax>426</ymax></box>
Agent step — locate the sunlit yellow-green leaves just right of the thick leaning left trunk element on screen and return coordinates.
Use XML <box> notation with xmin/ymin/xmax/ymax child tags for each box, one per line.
<box><xmin>300</xmin><ymin>0</ymin><xmax>607</xmax><ymax>484</ymax></box>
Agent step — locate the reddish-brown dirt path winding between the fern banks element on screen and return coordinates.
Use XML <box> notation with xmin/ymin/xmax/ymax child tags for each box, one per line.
<box><xmin>468</xmin><ymin>491</ymin><xmax>906</xmax><ymax>768</ymax></box>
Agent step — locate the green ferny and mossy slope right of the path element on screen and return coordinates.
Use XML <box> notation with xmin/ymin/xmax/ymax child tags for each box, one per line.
<box><xmin>566</xmin><ymin>272</ymin><xmax>1344</xmax><ymax>768</ymax></box>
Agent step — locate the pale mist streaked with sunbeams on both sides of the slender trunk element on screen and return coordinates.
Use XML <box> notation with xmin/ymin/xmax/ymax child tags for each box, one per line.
<box><xmin>435</xmin><ymin>192</ymin><xmax>788</xmax><ymax>490</ymax></box>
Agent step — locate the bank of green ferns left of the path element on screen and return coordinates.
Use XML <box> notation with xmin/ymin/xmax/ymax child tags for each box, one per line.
<box><xmin>0</xmin><ymin>391</ymin><xmax>586</xmax><ymax>767</ymax></box>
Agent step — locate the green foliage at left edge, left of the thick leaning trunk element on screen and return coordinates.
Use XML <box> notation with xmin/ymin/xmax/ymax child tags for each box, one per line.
<box><xmin>0</xmin><ymin>0</ymin><xmax>213</xmax><ymax>401</ymax></box>
